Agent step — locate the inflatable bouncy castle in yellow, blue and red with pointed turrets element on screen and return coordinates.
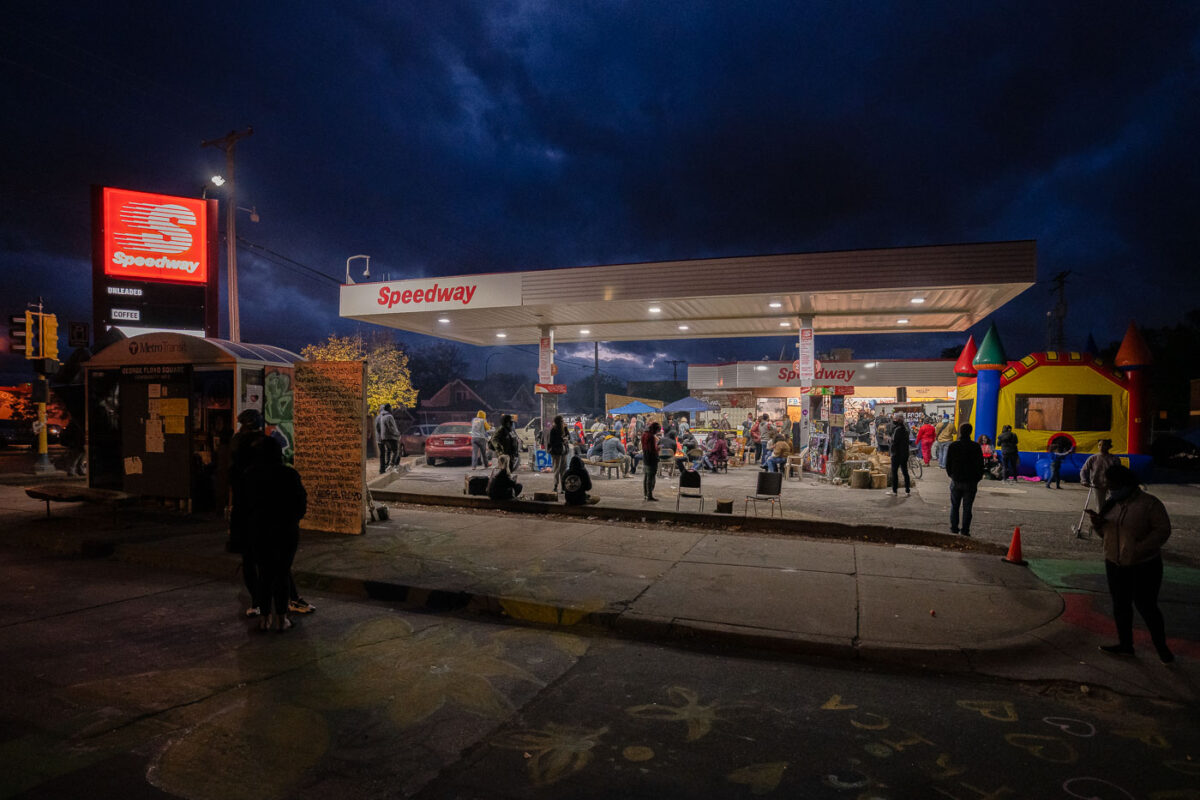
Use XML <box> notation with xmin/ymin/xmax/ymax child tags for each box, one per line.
<box><xmin>954</xmin><ymin>323</ymin><xmax>1151</xmax><ymax>480</ymax></box>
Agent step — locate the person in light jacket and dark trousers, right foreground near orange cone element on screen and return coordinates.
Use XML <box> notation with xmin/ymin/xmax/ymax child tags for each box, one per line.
<box><xmin>1087</xmin><ymin>464</ymin><xmax>1175</xmax><ymax>664</ymax></box>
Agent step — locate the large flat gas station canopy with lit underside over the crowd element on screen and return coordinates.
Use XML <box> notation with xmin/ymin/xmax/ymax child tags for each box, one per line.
<box><xmin>340</xmin><ymin>241</ymin><xmax>1037</xmax><ymax>345</ymax></box>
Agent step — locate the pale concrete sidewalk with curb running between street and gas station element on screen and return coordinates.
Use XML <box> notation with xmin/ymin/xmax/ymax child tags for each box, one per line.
<box><xmin>0</xmin><ymin>479</ymin><xmax>1200</xmax><ymax>702</ymax></box>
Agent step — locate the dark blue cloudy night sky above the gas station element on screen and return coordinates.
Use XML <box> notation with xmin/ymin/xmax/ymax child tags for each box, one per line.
<box><xmin>0</xmin><ymin>0</ymin><xmax>1200</xmax><ymax>381</ymax></box>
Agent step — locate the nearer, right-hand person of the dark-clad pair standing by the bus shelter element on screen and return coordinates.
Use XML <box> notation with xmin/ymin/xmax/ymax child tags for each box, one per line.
<box><xmin>246</xmin><ymin>437</ymin><xmax>308</xmax><ymax>631</ymax></box>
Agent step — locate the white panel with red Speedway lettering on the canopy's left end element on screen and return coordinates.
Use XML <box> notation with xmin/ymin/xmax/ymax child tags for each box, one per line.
<box><xmin>338</xmin><ymin>275</ymin><xmax>521</xmax><ymax>317</ymax></box>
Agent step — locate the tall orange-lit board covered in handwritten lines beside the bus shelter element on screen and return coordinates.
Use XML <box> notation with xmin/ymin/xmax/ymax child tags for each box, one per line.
<box><xmin>292</xmin><ymin>361</ymin><xmax>368</xmax><ymax>534</ymax></box>
